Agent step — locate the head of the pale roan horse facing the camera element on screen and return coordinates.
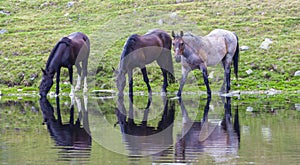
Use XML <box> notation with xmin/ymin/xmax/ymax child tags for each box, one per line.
<box><xmin>172</xmin><ymin>31</ymin><xmax>185</xmax><ymax>62</ymax></box>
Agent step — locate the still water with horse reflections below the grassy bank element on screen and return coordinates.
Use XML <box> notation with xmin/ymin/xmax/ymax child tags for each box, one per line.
<box><xmin>0</xmin><ymin>93</ymin><xmax>300</xmax><ymax>164</ymax></box>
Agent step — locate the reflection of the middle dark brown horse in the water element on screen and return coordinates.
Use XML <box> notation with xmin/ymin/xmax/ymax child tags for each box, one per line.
<box><xmin>116</xmin><ymin>97</ymin><xmax>175</xmax><ymax>156</ymax></box>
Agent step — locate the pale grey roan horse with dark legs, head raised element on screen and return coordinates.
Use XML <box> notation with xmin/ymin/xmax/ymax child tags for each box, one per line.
<box><xmin>172</xmin><ymin>29</ymin><xmax>239</xmax><ymax>97</ymax></box>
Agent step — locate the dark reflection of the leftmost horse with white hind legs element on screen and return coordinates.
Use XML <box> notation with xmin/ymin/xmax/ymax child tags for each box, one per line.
<box><xmin>40</xmin><ymin>97</ymin><xmax>92</xmax><ymax>160</ymax></box>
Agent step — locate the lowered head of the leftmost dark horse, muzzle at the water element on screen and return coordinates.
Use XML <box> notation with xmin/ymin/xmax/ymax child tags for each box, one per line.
<box><xmin>39</xmin><ymin>69</ymin><xmax>54</xmax><ymax>97</ymax></box>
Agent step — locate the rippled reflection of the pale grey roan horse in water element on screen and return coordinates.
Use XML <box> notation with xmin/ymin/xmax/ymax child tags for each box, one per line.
<box><xmin>175</xmin><ymin>97</ymin><xmax>240</xmax><ymax>163</ymax></box>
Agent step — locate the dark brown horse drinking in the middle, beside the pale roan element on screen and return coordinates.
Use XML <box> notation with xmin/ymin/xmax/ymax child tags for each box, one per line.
<box><xmin>116</xmin><ymin>29</ymin><xmax>175</xmax><ymax>96</ymax></box>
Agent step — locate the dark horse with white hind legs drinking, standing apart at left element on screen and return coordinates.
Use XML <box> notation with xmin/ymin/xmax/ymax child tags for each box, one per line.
<box><xmin>39</xmin><ymin>32</ymin><xmax>90</xmax><ymax>97</ymax></box>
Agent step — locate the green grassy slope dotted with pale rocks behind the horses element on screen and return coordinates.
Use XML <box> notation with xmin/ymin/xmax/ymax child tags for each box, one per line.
<box><xmin>0</xmin><ymin>0</ymin><xmax>300</xmax><ymax>93</ymax></box>
